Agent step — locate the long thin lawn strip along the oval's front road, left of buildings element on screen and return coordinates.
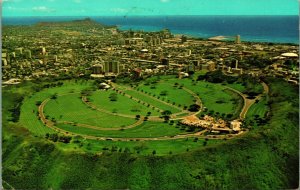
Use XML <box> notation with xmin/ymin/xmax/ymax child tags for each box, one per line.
<box><xmin>57</xmin><ymin>121</ymin><xmax>192</xmax><ymax>138</ymax></box>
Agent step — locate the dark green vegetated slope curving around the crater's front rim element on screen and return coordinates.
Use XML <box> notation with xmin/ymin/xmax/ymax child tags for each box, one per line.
<box><xmin>2</xmin><ymin>79</ymin><xmax>299</xmax><ymax>189</ymax></box>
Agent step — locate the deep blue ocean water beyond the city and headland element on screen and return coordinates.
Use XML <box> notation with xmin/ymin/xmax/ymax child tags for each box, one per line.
<box><xmin>2</xmin><ymin>16</ymin><xmax>299</xmax><ymax>44</ymax></box>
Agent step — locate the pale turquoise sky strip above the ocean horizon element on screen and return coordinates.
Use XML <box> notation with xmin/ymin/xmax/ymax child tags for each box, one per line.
<box><xmin>0</xmin><ymin>0</ymin><xmax>300</xmax><ymax>17</ymax></box>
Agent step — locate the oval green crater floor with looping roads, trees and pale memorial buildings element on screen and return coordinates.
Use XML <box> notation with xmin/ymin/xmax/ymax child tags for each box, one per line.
<box><xmin>11</xmin><ymin>72</ymin><xmax>267</xmax><ymax>155</ymax></box>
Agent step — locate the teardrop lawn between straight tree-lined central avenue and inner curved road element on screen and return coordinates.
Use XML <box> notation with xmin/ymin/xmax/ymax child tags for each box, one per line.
<box><xmin>89</xmin><ymin>90</ymin><xmax>159</xmax><ymax>116</ymax></box>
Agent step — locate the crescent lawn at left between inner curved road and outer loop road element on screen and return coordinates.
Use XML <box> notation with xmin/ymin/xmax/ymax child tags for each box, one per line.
<box><xmin>44</xmin><ymin>94</ymin><xmax>136</xmax><ymax>128</ymax></box>
